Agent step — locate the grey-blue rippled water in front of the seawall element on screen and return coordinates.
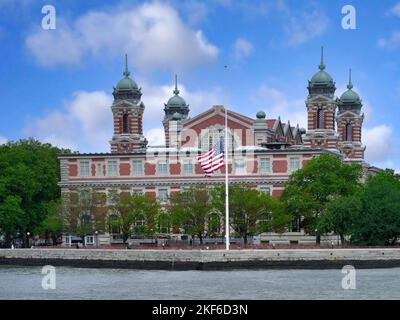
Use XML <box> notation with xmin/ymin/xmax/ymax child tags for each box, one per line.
<box><xmin>0</xmin><ymin>266</ymin><xmax>400</xmax><ymax>300</ymax></box>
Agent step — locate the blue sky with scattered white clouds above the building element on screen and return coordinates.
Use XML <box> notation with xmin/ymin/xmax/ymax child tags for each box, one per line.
<box><xmin>0</xmin><ymin>0</ymin><xmax>400</xmax><ymax>171</ymax></box>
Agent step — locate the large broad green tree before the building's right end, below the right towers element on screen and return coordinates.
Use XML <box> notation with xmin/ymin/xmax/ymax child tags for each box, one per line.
<box><xmin>281</xmin><ymin>155</ymin><xmax>362</xmax><ymax>243</ymax></box>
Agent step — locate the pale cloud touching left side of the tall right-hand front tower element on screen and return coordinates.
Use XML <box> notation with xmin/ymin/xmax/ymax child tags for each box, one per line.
<box><xmin>251</xmin><ymin>84</ymin><xmax>307</xmax><ymax>128</ymax></box>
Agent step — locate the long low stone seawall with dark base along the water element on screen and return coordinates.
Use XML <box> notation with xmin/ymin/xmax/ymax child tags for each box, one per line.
<box><xmin>0</xmin><ymin>248</ymin><xmax>400</xmax><ymax>270</ymax></box>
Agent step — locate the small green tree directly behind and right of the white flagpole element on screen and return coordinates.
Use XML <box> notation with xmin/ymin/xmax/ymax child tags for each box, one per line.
<box><xmin>214</xmin><ymin>185</ymin><xmax>286</xmax><ymax>244</ymax></box>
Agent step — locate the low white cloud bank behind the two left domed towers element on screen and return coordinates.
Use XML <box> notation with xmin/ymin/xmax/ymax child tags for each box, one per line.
<box><xmin>24</xmin><ymin>82</ymin><xmax>221</xmax><ymax>152</ymax></box>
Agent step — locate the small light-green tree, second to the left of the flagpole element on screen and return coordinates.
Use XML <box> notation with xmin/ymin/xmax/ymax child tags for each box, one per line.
<box><xmin>108</xmin><ymin>194</ymin><xmax>160</xmax><ymax>243</ymax></box>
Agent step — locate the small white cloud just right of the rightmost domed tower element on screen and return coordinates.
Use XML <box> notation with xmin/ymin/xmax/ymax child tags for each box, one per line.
<box><xmin>362</xmin><ymin>125</ymin><xmax>393</xmax><ymax>163</ymax></box>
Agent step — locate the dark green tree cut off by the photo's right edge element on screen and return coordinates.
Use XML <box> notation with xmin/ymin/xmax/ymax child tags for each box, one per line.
<box><xmin>351</xmin><ymin>171</ymin><xmax>400</xmax><ymax>245</ymax></box>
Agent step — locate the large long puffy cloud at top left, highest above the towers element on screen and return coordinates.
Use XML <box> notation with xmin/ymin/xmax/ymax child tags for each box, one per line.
<box><xmin>26</xmin><ymin>2</ymin><xmax>218</xmax><ymax>70</ymax></box>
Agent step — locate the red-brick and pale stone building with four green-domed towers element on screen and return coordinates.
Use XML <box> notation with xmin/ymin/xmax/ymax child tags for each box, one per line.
<box><xmin>59</xmin><ymin>48</ymin><xmax>369</xmax><ymax>244</ymax></box>
